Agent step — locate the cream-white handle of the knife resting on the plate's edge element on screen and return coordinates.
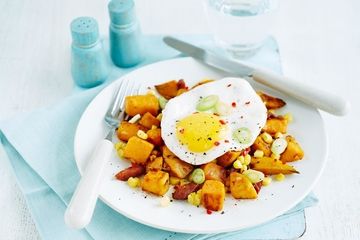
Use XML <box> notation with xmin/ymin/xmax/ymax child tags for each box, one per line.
<box><xmin>252</xmin><ymin>69</ymin><xmax>350</xmax><ymax>116</ymax></box>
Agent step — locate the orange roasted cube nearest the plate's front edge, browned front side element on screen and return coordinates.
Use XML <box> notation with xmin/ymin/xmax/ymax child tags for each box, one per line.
<box><xmin>201</xmin><ymin>180</ymin><xmax>225</xmax><ymax>211</ymax></box>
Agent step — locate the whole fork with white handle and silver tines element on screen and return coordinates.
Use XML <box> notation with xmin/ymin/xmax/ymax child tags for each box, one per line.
<box><xmin>64</xmin><ymin>79</ymin><xmax>135</xmax><ymax>229</ymax></box>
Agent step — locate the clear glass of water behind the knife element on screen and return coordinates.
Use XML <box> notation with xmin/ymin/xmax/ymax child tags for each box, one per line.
<box><xmin>203</xmin><ymin>0</ymin><xmax>278</xmax><ymax>58</ymax></box>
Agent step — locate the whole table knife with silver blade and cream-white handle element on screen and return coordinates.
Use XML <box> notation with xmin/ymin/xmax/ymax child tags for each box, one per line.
<box><xmin>163</xmin><ymin>36</ymin><xmax>350</xmax><ymax>116</ymax></box>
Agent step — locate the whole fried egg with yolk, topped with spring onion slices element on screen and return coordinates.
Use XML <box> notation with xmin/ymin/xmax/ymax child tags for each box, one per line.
<box><xmin>161</xmin><ymin>78</ymin><xmax>267</xmax><ymax>165</ymax></box>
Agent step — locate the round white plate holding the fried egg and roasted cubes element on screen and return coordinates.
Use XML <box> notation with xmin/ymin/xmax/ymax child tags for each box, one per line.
<box><xmin>74</xmin><ymin>58</ymin><xmax>327</xmax><ymax>233</ymax></box>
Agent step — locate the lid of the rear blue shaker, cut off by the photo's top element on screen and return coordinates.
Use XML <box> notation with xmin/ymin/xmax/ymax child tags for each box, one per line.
<box><xmin>108</xmin><ymin>0</ymin><xmax>136</xmax><ymax>25</ymax></box>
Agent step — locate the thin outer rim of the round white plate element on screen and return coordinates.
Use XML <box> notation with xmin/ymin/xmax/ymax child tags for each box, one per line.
<box><xmin>73</xmin><ymin>57</ymin><xmax>329</xmax><ymax>234</ymax></box>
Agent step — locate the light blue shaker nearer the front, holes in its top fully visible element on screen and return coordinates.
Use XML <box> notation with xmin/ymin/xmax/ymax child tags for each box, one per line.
<box><xmin>70</xmin><ymin>17</ymin><xmax>109</xmax><ymax>88</ymax></box>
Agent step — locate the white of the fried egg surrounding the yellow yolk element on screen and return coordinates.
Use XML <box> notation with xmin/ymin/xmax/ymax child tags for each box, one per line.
<box><xmin>161</xmin><ymin>78</ymin><xmax>267</xmax><ymax>165</ymax></box>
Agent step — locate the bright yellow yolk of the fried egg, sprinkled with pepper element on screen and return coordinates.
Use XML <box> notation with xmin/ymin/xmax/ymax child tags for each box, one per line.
<box><xmin>176</xmin><ymin>113</ymin><xmax>223</xmax><ymax>152</ymax></box>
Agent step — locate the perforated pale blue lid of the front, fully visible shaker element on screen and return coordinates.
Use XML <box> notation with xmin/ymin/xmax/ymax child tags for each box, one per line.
<box><xmin>70</xmin><ymin>17</ymin><xmax>99</xmax><ymax>46</ymax></box>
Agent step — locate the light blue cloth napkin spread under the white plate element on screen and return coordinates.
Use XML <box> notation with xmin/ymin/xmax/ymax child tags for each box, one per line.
<box><xmin>0</xmin><ymin>36</ymin><xmax>317</xmax><ymax>240</ymax></box>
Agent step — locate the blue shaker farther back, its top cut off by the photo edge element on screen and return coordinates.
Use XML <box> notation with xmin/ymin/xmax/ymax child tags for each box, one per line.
<box><xmin>108</xmin><ymin>0</ymin><xmax>143</xmax><ymax>67</ymax></box>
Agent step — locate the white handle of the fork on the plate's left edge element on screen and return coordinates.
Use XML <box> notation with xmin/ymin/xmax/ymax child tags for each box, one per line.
<box><xmin>64</xmin><ymin>139</ymin><xmax>114</xmax><ymax>229</ymax></box>
